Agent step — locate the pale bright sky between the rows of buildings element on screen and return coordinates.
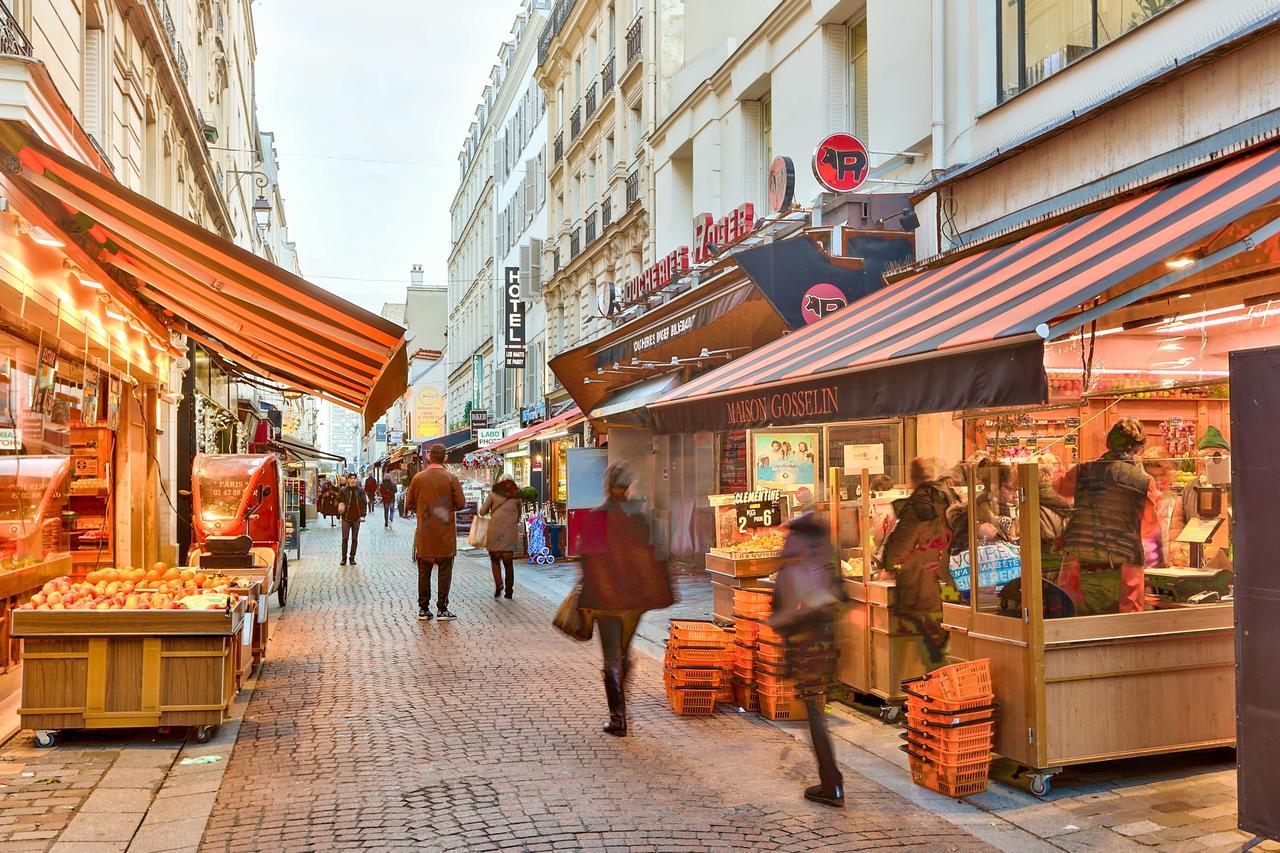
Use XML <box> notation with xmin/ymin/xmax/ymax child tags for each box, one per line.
<box><xmin>253</xmin><ymin>0</ymin><xmax>520</xmax><ymax>313</ymax></box>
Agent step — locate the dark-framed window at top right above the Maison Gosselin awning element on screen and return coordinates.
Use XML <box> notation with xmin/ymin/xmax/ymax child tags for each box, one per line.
<box><xmin>995</xmin><ymin>0</ymin><xmax>1183</xmax><ymax>101</ymax></box>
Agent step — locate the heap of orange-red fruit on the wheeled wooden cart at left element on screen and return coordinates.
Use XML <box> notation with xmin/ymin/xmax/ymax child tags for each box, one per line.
<box><xmin>18</xmin><ymin>562</ymin><xmax>236</xmax><ymax>610</ymax></box>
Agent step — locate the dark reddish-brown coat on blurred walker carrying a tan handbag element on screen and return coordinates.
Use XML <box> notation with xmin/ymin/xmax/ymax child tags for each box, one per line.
<box><xmin>580</xmin><ymin>498</ymin><xmax>675</xmax><ymax>612</ymax></box>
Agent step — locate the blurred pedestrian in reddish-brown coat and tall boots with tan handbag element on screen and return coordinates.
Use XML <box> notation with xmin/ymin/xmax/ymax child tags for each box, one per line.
<box><xmin>579</xmin><ymin>462</ymin><xmax>675</xmax><ymax>738</ymax></box>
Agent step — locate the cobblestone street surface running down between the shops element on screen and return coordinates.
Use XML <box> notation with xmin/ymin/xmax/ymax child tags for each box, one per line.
<box><xmin>201</xmin><ymin>523</ymin><xmax>987</xmax><ymax>850</ymax></box>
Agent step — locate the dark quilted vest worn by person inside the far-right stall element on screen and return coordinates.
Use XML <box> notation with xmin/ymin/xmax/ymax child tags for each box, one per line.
<box><xmin>1059</xmin><ymin>452</ymin><xmax>1152</xmax><ymax>569</ymax></box>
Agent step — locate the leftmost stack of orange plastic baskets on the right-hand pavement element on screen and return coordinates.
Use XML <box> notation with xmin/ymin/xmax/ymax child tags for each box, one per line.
<box><xmin>663</xmin><ymin>619</ymin><xmax>733</xmax><ymax>716</ymax></box>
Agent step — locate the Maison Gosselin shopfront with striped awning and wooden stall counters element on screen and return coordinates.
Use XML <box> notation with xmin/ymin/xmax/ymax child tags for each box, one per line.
<box><xmin>649</xmin><ymin>147</ymin><xmax>1280</xmax><ymax>793</ymax></box>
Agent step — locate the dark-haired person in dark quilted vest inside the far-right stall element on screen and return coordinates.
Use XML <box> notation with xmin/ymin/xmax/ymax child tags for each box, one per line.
<box><xmin>1057</xmin><ymin>418</ymin><xmax>1158</xmax><ymax>616</ymax></box>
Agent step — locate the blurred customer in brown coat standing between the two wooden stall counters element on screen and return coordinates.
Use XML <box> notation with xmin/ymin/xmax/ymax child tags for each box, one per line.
<box><xmin>881</xmin><ymin>457</ymin><xmax>956</xmax><ymax>666</ymax></box>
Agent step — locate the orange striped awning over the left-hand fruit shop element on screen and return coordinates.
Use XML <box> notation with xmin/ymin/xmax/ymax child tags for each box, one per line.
<box><xmin>0</xmin><ymin>122</ymin><xmax>408</xmax><ymax>429</ymax></box>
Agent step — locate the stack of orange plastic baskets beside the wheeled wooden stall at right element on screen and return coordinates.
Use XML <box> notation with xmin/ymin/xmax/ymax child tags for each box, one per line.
<box><xmin>902</xmin><ymin>658</ymin><xmax>996</xmax><ymax>797</ymax></box>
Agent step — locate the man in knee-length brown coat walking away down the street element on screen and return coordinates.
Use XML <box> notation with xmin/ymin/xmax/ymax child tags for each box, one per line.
<box><xmin>404</xmin><ymin>444</ymin><xmax>467</xmax><ymax>621</ymax></box>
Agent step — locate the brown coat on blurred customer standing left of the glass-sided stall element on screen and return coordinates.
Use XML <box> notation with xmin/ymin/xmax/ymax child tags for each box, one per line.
<box><xmin>881</xmin><ymin>483</ymin><xmax>956</xmax><ymax>613</ymax></box>
